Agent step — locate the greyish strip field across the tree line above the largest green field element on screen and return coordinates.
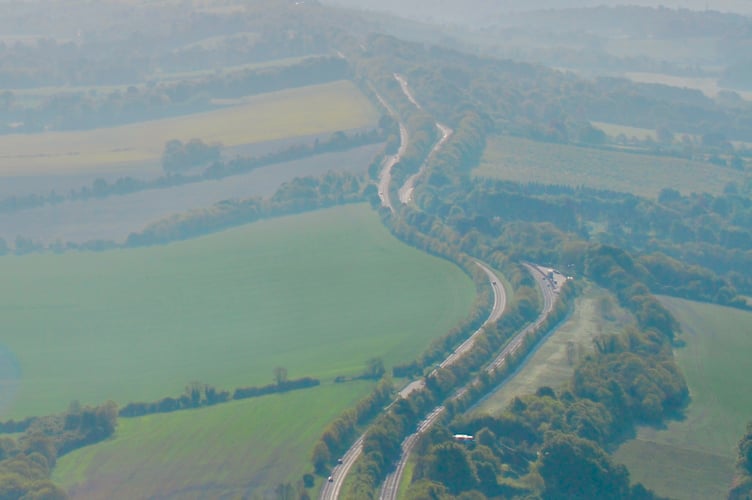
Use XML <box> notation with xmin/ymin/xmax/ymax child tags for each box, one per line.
<box><xmin>0</xmin><ymin>144</ymin><xmax>382</xmax><ymax>244</ymax></box>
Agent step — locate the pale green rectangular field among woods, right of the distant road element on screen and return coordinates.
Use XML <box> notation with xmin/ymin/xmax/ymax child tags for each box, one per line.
<box><xmin>473</xmin><ymin>136</ymin><xmax>744</xmax><ymax>197</ymax></box>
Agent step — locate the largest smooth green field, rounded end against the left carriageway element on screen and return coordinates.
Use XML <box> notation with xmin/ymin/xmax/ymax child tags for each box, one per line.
<box><xmin>0</xmin><ymin>205</ymin><xmax>475</xmax><ymax>419</ymax></box>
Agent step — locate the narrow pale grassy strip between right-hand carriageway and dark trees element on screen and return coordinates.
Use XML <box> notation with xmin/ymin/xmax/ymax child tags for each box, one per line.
<box><xmin>473</xmin><ymin>286</ymin><xmax>629</xmax><ymax>415</ymax></box>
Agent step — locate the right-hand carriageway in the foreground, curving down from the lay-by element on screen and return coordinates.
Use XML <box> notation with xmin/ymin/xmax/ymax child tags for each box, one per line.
<box><xmin>379</xmin><ymin>263</ymin><xmax>561</xmax><ymax>500</ymax></box>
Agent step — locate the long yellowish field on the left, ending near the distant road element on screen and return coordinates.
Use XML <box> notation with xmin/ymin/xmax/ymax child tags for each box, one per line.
<box><xmin>0</xmin><ymin>81</ymin><xmax>378</xmax><ymax>176</ymax></box>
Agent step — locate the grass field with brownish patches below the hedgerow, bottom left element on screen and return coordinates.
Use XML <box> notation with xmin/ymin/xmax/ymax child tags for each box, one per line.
<box><xmin>53</xmin><ymin>382</ymin><xmax>372</xmax><ymax>499</ymax></box>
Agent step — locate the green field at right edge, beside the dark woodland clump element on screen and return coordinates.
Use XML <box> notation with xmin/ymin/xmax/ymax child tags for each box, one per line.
<box><xmin>614</xmin><ymin>297</ymin><xmax>752</xmax><ymax>499</ymax></box>
